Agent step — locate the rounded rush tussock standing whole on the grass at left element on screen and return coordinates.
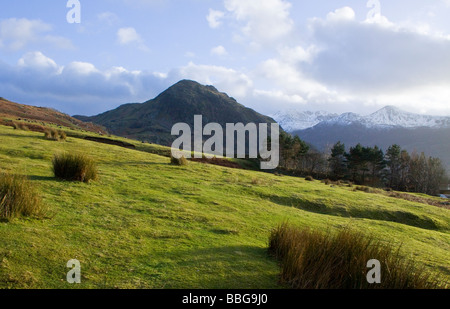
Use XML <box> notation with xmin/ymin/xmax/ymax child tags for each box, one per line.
<box><xmin>52</xmin><ymin>153</ymin><xmax>98</xmax><ymax>183</ymax></box>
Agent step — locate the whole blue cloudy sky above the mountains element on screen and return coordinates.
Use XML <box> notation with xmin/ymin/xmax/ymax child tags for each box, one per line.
<box><xmin>0</xmin><ymin>0</ymin><xmax>450</xmax><ymax>116</ymax></box>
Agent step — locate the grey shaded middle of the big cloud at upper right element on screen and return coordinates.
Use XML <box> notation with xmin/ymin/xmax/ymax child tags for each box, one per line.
<box><xmin>308</xmin><ymin>10</ymin><xmax>450</xmax><ymax>93</ymax></box>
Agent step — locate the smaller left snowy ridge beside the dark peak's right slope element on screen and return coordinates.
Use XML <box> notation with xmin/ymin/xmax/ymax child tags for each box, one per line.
<box><xmin>271</xmin><ymin>110</ymin><xmax>338</xmax><ymax>132</ymax></box>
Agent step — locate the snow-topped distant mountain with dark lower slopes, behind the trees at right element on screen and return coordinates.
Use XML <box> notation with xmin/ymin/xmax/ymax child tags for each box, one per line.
<box><xmin>292</xmin><ymin>106</ymin><xmax>450</xmax><ymax>171</ymax></box>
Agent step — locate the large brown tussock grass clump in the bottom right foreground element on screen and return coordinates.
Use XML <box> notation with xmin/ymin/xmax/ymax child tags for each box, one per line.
<box><xmin>269</xmin><ymin>223</ymin><xmax>444</xmax><ymax>289</ymax></box>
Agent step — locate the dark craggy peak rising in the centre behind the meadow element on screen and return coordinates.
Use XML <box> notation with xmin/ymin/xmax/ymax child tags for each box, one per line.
<box><xmin>74</xmin><ymin>80</ymin><xmax>275</xmax><ymax>145</ymax></box>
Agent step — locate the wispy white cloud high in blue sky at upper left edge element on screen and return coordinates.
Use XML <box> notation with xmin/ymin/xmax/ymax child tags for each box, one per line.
<box><xmin>0</xmin><ymin>18</ymin><xmax>73</xmax><ymax>51</ymax></box>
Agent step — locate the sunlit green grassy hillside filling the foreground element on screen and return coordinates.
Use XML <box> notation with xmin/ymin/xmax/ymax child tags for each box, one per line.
<box><xmin>0</xmin><ymin>126</ymin><xmax>450</xmax><ymax>288</ymax></box>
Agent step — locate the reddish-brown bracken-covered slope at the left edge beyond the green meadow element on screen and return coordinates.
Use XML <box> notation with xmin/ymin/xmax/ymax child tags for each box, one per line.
<box><xmin>0</xmin><ymin>97</ymin><xmax>106</xmax><ymax>133</ymax></box>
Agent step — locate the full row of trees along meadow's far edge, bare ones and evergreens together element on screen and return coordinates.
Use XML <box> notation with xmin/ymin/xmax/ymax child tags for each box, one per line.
<box><xmin>280</xmin><ymin>134</ymin><xmax>446</xmax><ymax>195</ymax></box>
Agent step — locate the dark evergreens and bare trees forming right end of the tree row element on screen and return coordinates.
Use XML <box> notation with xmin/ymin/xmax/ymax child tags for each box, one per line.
<box><xmin>328</xmin><ymin>142</ymin><xmax>446</xmax><ymax>195</ymax></box>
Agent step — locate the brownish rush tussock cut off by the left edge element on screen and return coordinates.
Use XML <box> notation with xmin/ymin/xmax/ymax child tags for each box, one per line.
<box><xmin>0</xmin><ymin>173</ymin><xmax>42</xmax><ymax>219</ymax></box>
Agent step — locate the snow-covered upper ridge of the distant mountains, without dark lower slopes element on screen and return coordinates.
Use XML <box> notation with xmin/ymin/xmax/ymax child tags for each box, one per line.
<box><xmin>272</xmin><ymin>106</ymin><xmax>450</xmax><ymax>132</ymax></box>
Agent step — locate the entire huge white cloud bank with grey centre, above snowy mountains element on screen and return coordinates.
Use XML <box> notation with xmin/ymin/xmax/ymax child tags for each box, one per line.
<box><xmin>244</xmin><ymin>8</ymin><xmax>450</xmax><ymax>114</ymax></box>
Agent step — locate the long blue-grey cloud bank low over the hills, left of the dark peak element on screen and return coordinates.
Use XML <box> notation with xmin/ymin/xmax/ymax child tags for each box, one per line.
<box><xmin>0</xmin><ymin>52</ymin><xmax>168</xmax><ymax>114</ymax></box>
